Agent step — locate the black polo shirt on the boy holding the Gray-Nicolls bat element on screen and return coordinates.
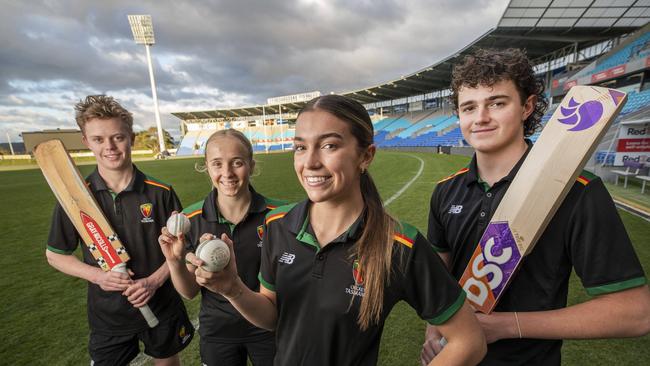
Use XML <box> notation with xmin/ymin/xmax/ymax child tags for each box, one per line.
<box><xmin>47</xmin><ymin>166</ymin><xmax>185</xmax><ymax>335</ymax></box>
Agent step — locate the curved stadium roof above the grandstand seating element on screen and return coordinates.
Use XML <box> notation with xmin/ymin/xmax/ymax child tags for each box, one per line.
<box><xmin>172</xmin><ymin>0</ymin><xmax>650</xmax><ymax>120</ymax></box>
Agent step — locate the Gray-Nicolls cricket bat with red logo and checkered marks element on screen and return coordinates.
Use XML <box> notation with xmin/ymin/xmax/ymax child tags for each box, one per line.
<box><xmin>34</xmin><ymin>140</ymin><xmax>158</xmax><ymax>328</ymax></box>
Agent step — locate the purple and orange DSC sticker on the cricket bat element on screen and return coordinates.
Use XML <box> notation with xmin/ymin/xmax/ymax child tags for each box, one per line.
<box><xmin>460</xmin><ymin>222</ymin><xmax>521</xmax><ymax>313</ymax></box>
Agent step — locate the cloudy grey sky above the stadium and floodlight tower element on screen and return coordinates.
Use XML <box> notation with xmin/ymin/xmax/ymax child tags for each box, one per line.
<box><xmin>0</xmin><ymin>0</ymin><xmax>508</xmax><ymax>142</ymax></box>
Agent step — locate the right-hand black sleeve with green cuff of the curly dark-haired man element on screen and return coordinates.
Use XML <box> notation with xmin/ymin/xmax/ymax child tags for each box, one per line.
<box><xmin>566</xmin><ymin>178</ymin><xmax>646</xmax><ymax>296</ymax></box>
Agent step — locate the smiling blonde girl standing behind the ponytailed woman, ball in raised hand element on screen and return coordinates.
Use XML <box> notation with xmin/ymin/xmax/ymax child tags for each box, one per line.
<box><xmin>159</xmin><ymin>129</ymin><xmax>285</xmax><ymax>366</ymax></box>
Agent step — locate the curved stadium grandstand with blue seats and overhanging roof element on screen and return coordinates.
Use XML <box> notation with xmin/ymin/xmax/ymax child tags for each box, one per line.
<box><xmin>173</xmin><ymin>0</ymin><xmax>650</xmax><ymax>173</ymax></box>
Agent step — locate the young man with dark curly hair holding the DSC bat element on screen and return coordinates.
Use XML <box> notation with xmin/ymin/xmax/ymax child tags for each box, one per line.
<box><xmin>422</xmin><ymin>49</ymin><xmax>650</xmax><ymax>365</ymax></box>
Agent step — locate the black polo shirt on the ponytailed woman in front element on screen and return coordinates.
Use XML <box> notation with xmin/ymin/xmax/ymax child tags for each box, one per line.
<box><xmin>260</xmin><ymin>201</ymin><xmax>465</xmax><ymax>366</ymax></box>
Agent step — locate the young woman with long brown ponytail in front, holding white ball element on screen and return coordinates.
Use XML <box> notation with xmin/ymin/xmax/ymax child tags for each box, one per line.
<box><xmin>190</xmin><ymin>95</ymin><xmax>486</xmax><ymax>365</ymax></box>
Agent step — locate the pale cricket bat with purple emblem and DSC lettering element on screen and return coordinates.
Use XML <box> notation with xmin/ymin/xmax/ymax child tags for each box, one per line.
<box><xmin>460</xmin><ymin>86</ymin><xmax>627</xmax><ymax>314</ymax></box>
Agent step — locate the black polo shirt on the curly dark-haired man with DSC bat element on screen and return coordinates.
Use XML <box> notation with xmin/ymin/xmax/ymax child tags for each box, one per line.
<box><xmin>428</xmin><ymin>145</ymin><xmax>646</xmax><ymax>365</ymax></box>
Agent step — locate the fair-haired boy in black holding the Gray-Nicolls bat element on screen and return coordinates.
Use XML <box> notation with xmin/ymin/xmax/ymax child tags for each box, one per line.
<box><xmin>46</xmin><ymin>95</ymin><xmax>194</xmax><ymax>365</ymax></box>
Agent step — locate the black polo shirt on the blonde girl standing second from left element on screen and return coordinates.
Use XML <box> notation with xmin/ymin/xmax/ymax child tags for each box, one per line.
<box><xmin>183</xmin><ymin>187</ymin><xmax>286</xmax><ymax>343</ymax></box>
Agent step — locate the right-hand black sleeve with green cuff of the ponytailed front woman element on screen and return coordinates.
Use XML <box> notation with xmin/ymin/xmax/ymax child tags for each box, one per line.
<box><xmin>403</xmin><ymin>233</ymin><xmax>465</xmax><ymax>324</ymax></box>
